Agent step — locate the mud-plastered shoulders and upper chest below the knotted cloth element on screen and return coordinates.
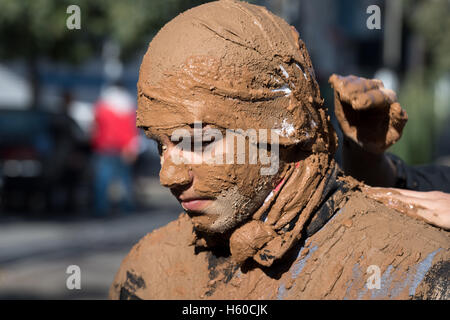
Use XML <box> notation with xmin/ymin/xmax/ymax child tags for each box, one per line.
<box><xmin>110</xmin><ymin>192</ymin><xmax>450</xmax><ymax>299</ymax></box>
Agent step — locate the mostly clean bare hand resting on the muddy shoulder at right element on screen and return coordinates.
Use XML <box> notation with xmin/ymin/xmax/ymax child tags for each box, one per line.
<box><xmin>365</xmin><ymin>187</ymin><xmax>450</xmax><ymax>230</ymax></box>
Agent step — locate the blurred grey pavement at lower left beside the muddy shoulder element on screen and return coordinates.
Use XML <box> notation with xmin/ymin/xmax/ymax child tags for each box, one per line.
<box><xmin>0</xmin><ymin>179</ymin><xmax>181</xmax><ymax>299</ymax></box>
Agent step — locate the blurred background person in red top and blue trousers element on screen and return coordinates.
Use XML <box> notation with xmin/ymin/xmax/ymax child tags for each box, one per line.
<box><xmin>92</xmin><ymin>84</ymin><xmax>139</xmax><ymax>216</ymax></box>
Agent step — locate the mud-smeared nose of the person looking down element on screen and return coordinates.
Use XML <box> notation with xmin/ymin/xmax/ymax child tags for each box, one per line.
<box><xmin>159</xmin><ymin>152</ymin><xmax>192</xmax><ymax>188</ymax></box>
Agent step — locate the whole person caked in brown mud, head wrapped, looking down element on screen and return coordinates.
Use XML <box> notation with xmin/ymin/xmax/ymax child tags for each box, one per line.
<box><xmin>110</xmin><ymin>1</ymin><xmax>449</xmax><ymax>299</ymax></box>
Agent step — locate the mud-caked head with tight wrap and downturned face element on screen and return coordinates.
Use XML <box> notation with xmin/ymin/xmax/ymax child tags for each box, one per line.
<box><xmin>137</xmin><ymin>1</ymin><xmax>329</xmax><ymax>233</ymax></box>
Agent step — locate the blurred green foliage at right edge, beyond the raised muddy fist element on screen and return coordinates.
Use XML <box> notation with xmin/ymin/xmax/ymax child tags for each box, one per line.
<box><xmin>390</xmin><ymin>0</ymin><xmax>450</xmax><ymax>164</ymax></box>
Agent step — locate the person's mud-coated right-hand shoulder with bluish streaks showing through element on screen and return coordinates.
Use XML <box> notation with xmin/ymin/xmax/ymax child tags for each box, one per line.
<box><xmin>296</xmin><ymin>192</ymin><xmax>450</xmax><ymax>299</ymax></box>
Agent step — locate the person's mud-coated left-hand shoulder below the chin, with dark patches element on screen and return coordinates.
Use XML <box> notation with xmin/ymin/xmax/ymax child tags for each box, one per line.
<box><xmin>109</xmin><ymin>213</ymin><xmax>206</xmax><ymax>299</ymax></box>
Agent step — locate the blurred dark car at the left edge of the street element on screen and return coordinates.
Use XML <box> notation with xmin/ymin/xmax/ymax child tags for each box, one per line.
<box><xmin>0</xmin><ymin>109</ymin><xmax>89</xmax><ymax>212</ymax></box>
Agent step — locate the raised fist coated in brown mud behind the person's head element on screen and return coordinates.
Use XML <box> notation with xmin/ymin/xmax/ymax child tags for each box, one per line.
<box><xmin>328</xmin><ymin>74</ymin><xmax>408</xmax><ymax>154</ymax></box>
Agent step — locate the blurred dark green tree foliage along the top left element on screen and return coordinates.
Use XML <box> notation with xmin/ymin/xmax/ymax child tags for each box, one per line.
<box><xmin>0</xmin><ymin>0</ymin><xmax>208</xmax><ymax>106</ymax></box>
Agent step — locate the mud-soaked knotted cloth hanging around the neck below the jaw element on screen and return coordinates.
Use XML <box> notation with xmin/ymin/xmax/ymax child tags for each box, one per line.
<box><xmin>196</xmin><ymin>156</ymin><xmax>358</xmax><ymax>267</ymax></box>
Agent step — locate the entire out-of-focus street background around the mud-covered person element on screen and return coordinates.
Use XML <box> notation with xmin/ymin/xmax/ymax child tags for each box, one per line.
<box><xmin>0</xmin><ymin>0</ymin><xmax>450</xmax><ymax>299</ymax></box>
